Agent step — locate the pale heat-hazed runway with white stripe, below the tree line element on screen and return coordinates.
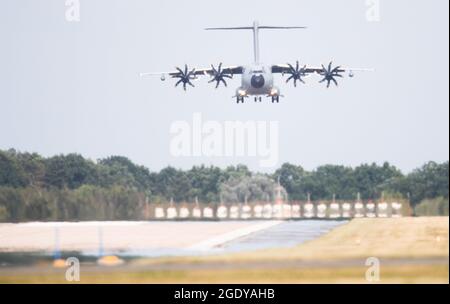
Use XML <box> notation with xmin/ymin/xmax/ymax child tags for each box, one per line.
<box><xmin>0</xmin><ymin>220</ymin><xmax>344</xmax><ymax>257</ymax></box>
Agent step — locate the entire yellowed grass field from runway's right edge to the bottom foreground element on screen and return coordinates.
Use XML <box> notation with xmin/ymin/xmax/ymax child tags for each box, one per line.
<box><xmin>0</xmin><ymin>217</ymin><xmax>449</xmax><ymax>283</ymax></box>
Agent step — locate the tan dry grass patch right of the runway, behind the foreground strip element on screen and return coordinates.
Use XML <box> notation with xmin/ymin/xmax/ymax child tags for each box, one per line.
<box><xmin>229</xmin><ymin>217</ymin><xmax>449</xmax><ymax>260</ymax></box>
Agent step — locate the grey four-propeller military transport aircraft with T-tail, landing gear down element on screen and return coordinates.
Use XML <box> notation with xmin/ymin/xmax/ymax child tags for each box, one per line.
<box><xmin>140</xmin><ymin>21</ymin><xmax>371</xmax><ymax>103</ymax></box>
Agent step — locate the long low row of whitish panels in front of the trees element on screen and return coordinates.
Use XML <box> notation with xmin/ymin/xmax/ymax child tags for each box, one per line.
<box><xmin>145</xmin><ymin>200</ymin><xmax>410</xmax><ymax>220</ymax></box>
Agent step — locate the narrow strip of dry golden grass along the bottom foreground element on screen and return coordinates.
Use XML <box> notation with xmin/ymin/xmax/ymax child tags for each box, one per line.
<box><xmin>0</xmin><ymin>265</ymin><xmax>449</xmax><ymax>284</ymax></box>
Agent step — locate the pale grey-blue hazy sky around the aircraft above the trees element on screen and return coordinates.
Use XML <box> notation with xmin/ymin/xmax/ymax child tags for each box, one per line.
<box><xmin>0</xmin><ymin>0</ymin><xmax>449</xmax><ymax>172</ymax></box>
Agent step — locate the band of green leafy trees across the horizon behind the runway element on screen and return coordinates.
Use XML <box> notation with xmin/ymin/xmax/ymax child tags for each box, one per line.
<box><xmin>0</xmin><ymin>149</ymin><xmax>449</xmax><ymax>221</ymax></box>
